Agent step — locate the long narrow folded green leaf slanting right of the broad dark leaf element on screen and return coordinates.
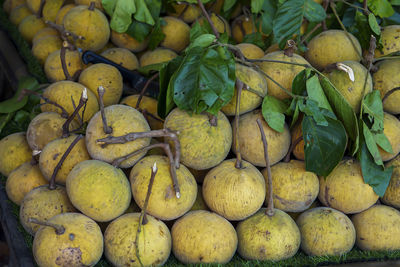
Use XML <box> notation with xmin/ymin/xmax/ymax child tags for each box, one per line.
<box><xmin>320</xmin><ymin>77</ymin><xmax>359</xmax><ymax>155</ymax></box>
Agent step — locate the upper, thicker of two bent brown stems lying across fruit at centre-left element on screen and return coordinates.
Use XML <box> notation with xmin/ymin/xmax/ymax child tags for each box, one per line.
<box><xmin>97</xmin><ymin>128</ymin><xmax>181</xmax><ymax>169</ymax></box>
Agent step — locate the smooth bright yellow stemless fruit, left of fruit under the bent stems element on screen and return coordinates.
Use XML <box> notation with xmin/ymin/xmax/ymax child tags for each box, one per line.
<box><xmin>66</xmin><ymin>160</ymin><xmax>132</xmax><ymax>222</ymax></box>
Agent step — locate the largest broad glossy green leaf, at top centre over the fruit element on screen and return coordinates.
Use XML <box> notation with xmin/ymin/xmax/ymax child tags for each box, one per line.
<box><xmin>170</xmin><ymin>47</ymin><xmax>236</xmax><ymax>115</ymax></box>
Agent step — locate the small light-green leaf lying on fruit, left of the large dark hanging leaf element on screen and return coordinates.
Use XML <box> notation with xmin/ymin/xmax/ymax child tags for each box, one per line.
<box><xmin>262</xmin><ymin>95</ymin><xmax>288</xmax><ymax>133</ymax></box>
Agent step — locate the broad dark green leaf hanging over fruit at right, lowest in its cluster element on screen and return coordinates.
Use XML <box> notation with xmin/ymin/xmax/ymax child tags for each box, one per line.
<box><xmin>302</xmin><ymin>116</ymin><xmax>347</xmax><ymax>177</ymax></box>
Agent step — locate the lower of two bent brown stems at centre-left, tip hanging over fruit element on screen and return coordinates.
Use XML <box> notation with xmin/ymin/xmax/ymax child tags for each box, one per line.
<box><xmin>112</xmin><ymin>143</ymin><xmax>181</xmax><ymax>198</ymax></box>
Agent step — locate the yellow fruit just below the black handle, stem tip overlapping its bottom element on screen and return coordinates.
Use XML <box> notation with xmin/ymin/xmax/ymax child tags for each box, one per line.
<box><xmin>79</xmin><ymin>63</ymin><xmax>124</xmax><ymax>106</ymax></box>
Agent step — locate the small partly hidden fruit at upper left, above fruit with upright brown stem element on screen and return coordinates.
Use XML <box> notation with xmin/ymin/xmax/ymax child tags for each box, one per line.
<box><xmin>32</xmin><ymin>36</ymin><xmax>62</xmax><ymax>65</ymax></box>
